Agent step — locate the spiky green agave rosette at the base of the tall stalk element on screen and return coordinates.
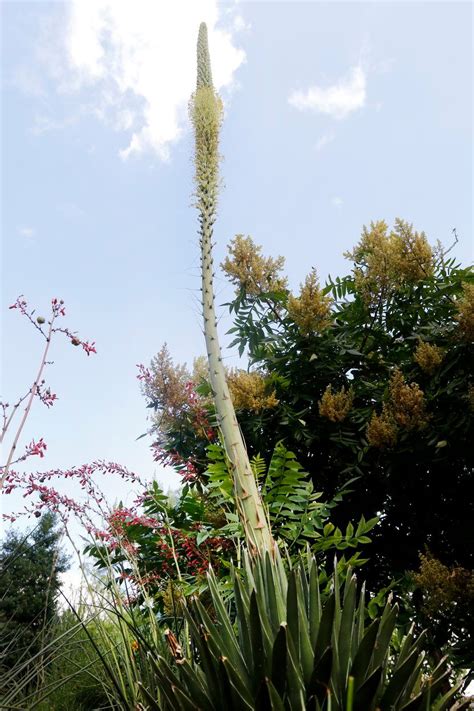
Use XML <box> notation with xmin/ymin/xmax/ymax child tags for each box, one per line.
<box><xmin>142</xmin><ymin>554</ymin><xmax>465</xmax><ymax>711</ymax></box>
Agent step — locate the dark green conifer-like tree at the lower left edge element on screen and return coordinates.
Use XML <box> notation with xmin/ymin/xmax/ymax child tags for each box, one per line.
<box><xmin>0</xmin><ymin>513</ymin><xmax>68</xmax><ymax>668</ymax></box>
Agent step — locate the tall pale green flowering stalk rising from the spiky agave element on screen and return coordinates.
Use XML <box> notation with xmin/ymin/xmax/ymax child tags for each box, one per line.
<box><xmin>190</xmin><ymin>23</ymin><xmax>275</xmax><ymax>554</ymax></box>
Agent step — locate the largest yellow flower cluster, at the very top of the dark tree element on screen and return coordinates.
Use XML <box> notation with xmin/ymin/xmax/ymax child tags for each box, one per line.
<box><xmin>345</xmin><ymin>219</ymin><xmax>435</xmax><ymax>304</ymax></box>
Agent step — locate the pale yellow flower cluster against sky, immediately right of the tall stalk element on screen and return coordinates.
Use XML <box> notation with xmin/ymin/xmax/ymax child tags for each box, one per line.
<box><xmin>221</xmin><ymin>235</ymin><xmax>287</xmax><ymax>296</ymax></box>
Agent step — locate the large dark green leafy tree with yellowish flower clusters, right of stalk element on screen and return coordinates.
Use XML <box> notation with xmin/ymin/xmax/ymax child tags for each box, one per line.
<box><xmin>220</xmin><ymin>229</ymin><xmax>474</xmax><ymax>644</ymax></box>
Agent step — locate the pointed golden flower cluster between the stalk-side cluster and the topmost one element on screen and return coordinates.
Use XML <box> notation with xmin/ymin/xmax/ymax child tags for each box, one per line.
<box><xmin>288</xmin><ymin>269</ymin><xmax>332</xmax><ymax>336</ymax></box>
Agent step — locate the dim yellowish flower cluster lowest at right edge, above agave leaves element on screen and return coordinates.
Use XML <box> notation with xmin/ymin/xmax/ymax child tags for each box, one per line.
<box><xmin>414</xmin><ymin>555</ymin><xmax>474</xmax><ymax>615</ymax></box>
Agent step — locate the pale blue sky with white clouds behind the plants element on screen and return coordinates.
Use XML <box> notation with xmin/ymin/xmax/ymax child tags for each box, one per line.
<box><xmin>1</xmin><ymin>0</ymin><xmax>473</xmax><ymax>524</ymax></box>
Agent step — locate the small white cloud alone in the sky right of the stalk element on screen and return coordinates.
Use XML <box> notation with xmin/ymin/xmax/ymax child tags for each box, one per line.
<box><xmin>288</xmin><ymin>65</ymin><xmax>367</xmax><ymax>119</ymax></box>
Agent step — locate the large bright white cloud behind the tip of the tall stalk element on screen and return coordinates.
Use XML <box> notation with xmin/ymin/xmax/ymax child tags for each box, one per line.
<box><xmin>40</xmin><ymin>0</ymin><xmax>245</xmax><ymax>160</ymax></box>
